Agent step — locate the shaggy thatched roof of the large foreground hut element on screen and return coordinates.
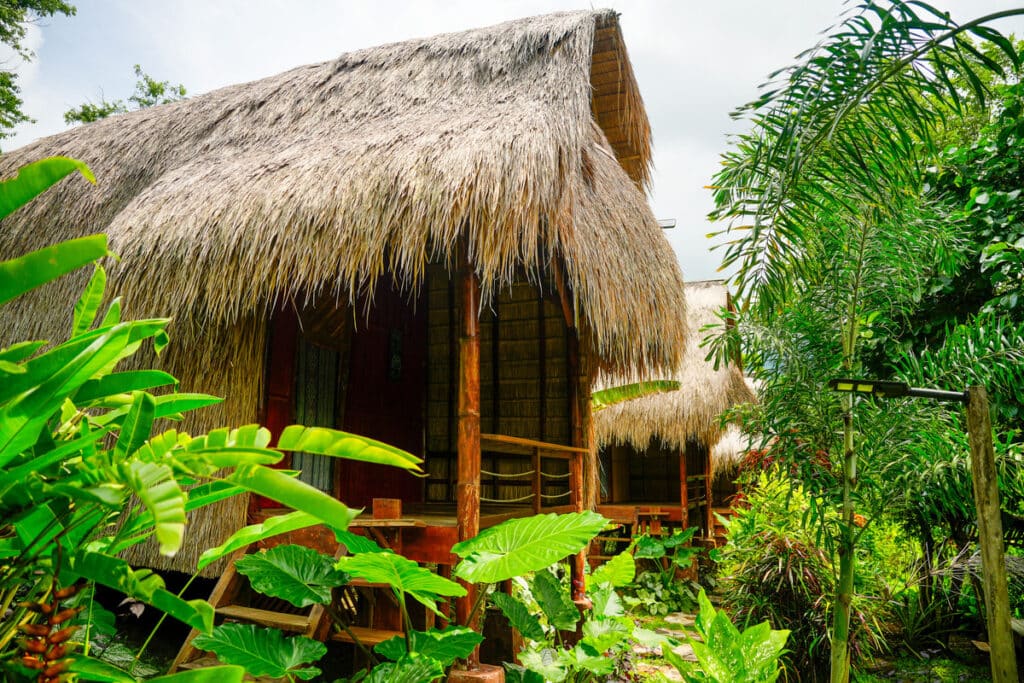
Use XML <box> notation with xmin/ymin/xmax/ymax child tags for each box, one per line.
<box><xmin>0</xmin><ymin>10</ymin><xmax>686</xmax><ymax>376</ymax></box>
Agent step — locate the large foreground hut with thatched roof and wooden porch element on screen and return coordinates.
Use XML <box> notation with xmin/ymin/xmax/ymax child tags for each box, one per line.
<box><xmin>0</xmin><ymin>10</ymin><xmax>687</xmax><ymax>643</ymax></box>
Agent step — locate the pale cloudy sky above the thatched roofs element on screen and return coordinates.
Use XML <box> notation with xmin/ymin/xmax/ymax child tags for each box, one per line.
<box><xmin>6</xmin><ymin>0</ymin><xmax>1024</xmax><ymax>281</ymax></box>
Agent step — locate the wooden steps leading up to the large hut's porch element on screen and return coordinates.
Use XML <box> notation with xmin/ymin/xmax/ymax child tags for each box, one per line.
<box><xmin>170</xmin><ymin>546</ymin><xmax>404</xmax><ymax>673</ymax></box>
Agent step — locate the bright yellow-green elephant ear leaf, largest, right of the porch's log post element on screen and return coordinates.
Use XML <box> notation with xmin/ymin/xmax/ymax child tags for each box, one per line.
<box><xmin>452</xmin><ymin>511</ymin><xmax>608</xmax><ymax>584</ymax></box>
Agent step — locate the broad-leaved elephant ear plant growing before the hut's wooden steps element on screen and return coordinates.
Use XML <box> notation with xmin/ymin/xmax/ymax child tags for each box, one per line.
<box><xmin>194</xmin><ymin>512</ymin><xmax>621</xmax><ymax>683</ymax></box>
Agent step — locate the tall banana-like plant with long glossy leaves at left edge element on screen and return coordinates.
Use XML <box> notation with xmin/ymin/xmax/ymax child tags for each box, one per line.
<box><xmin>0</xmin><ymin>158</ymin><xmax>419</xmax><ymax>681</ymax></box>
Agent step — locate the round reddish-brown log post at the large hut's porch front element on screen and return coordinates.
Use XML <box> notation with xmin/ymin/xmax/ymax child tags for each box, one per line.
<box><xmin>456</xmin><ymin>243</ymin><xmax>480</xmax><ymax>669</ymax></box>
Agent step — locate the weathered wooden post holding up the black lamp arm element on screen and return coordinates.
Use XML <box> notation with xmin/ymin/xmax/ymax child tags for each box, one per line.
<box><xmin>967</xmin><ymin>386</ymin><xmax>1017</xmax><ymax>683</ymax></box>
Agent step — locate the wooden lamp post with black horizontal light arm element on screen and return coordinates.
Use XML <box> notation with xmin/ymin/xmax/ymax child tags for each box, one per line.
<box><xmin>828</xmin><ymin>378</ymin><xmax>1017</xmax><ymax>683</ymax></box>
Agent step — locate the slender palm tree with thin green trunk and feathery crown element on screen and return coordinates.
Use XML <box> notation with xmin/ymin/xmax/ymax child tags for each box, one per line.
<box><xmin>713</xmin><ymin>1</ymin><xmax>1024</xmax><ymax>681</ymax></box>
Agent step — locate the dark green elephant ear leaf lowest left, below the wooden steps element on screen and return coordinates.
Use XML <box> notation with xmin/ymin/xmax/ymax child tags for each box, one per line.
<box><xmin>193</xmin><ymin>624</ymin><xmax>327</xmax><ymax>681</ymax></box>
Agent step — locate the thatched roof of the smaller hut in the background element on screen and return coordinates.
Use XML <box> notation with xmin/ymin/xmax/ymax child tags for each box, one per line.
<box><xmin>594</xmin><ymin>281</ymin><xmax>756</xmax><ymax>471</ymax></box>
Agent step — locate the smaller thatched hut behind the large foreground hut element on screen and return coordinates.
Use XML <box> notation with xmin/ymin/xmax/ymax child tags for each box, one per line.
<box><xmin>594</xmin><ymin>281</ymin><xmax>755</xmax><ymax>539</ymax></box>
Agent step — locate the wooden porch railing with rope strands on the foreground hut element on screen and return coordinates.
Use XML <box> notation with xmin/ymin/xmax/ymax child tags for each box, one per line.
<box><xmin>480</xmin><ymin>434</ymin><xmax>587</xmax><ymax>513</ymax></box>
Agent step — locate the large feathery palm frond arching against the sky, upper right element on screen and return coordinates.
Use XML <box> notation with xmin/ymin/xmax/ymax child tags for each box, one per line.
<box><xmin>711</xmin><ymin>0</ymin><xmax>1024</xmax><ymax>312</ymax></box>
